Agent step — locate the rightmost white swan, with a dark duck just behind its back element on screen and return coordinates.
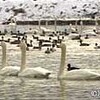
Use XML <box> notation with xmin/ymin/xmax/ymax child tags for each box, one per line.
<box><xmin>57</xmin><ymin>43</ymin><xmax>100</xmax><ymax>80</ymax></box>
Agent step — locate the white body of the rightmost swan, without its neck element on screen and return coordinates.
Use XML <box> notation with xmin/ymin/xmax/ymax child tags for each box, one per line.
<box><xmin>60</xmin><ymin>69</ymin><xmax>100</xmax><ymax>80</ymax></box>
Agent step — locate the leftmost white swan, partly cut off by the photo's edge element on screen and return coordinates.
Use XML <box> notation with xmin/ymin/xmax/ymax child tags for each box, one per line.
<box><xmin>0</xmin><ymin>41</ymin><xmax>20</xmax><ymax>76</ymax></box>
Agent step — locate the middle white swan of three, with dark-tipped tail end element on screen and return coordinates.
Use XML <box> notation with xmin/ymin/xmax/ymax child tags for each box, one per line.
<box><xmin>18</xmin><ymin>41</ymin><xmax>51</xmax><ymax>78</ymax></box>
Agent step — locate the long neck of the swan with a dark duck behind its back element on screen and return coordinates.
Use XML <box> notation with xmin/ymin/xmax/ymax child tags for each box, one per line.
<box><xmin>58</xmin><ymin>43</ymin><xmax>66</xmax><ymax>78</ymax></box>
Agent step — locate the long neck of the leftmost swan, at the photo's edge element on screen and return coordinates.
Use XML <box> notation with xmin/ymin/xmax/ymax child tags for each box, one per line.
<box><xmin>1</xmin><ymin>41</ymin><xmax>6</xmax><ymax>68</ymax></box>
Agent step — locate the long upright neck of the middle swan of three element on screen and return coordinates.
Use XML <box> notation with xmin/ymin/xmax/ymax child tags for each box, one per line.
<box><xmin>20</xmin><ymin>40</ymin><xmax>27</xmax><ymax>71</ymax></box>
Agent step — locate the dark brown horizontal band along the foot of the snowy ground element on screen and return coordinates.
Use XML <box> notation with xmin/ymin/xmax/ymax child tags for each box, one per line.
<box><xmin>2</xmin><ymin>19</ymin><xmax>100</xmax><ymax>25</ymax></box>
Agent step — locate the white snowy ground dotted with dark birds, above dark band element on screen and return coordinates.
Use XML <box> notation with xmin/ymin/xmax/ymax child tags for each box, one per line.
<box><xmin>0</xmin><ymin>0</ymin><xmax>100</xmax><ymax>22</ymax></box>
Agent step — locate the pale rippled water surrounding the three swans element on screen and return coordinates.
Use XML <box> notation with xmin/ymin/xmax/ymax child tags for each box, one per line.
<box><xmin>0</xmin><ymin>26</ymin><xmax>100</xmax><ymax>100</ymax></box>
